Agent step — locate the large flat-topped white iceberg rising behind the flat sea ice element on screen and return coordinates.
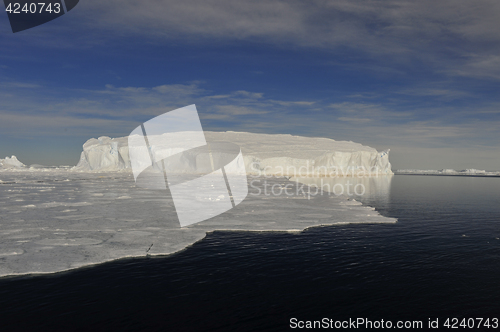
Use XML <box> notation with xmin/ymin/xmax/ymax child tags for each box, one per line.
<box><xmin>74</xmin><ymin>132</ymin><xmax>392</xmax><ymax>177</ymax></box>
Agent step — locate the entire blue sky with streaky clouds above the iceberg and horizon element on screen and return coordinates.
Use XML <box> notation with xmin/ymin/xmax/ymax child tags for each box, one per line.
<box><xmin>0</xmin><ymin>0</ymin><xmax>500</xmax><ymax>170</ymax></box>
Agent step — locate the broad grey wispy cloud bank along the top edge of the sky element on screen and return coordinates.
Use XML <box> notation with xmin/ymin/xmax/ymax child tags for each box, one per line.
<box><xmin>64</xmin><ymin>0</ymin><xmax>500</xmax><ymax>74</ymax></box>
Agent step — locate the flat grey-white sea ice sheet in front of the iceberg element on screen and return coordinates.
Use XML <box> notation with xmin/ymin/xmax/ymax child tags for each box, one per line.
<box><xmin>0</xmin><ymin>169</ymin><xmax>396</xmax><ymax>276</ymax></box>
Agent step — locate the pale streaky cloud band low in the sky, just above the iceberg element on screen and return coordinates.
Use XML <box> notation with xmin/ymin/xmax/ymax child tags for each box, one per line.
<box><xmin>0</xmin><ymin>82</ymin><xmax>492</xmax><ymax>141</ymax></box>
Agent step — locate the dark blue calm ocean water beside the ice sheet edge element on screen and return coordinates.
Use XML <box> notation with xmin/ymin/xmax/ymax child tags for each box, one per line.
<box><xmin>0</xmin><ymin>175</ymin><xmax>500</xmax><ymax>331</ymax></box>
